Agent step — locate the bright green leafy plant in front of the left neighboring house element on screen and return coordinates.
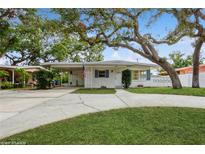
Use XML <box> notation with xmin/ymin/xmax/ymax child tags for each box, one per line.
<box><xmin>15</xmin><ymin>68</ymin><xmax>30</xmax><ymax>87</ymax></box>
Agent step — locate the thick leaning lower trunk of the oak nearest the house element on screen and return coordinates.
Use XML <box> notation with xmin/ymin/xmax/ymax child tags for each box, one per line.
<box><xmin>158</xmin><ymin>60</ymin><xmax>182</xmax><ymax>89</ymax></box>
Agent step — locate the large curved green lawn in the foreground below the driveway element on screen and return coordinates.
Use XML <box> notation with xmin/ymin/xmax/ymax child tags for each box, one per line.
<box><xmin>0</xmin><ymin>107</ymin><xmax>205</xmax><ymax>145</ymax></box>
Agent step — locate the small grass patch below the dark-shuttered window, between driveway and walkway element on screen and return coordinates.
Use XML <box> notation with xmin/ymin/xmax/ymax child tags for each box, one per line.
<box><xmin>73</xmin><ymin>88</ymin><xmax>116</xmax><ymax>94</ymax></box>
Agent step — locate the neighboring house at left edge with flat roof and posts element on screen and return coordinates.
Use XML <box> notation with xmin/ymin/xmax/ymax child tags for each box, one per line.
<box><xmin>0</xmin><ymin>65</ymin><xmax>45</xmax><ymax>84</ymax></box>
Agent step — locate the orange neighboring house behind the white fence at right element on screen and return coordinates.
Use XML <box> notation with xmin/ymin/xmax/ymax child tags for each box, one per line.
<box><xmin>176</xmin><ymin>64</ymin><xmax>205</xmax><ymax>75</ymax></box>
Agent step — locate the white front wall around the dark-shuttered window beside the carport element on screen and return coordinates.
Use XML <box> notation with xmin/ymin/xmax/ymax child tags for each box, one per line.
<box><xmin>85</xmin><ymin>67</ymin><xmax>122</xmax><ymax>88</ymax></box>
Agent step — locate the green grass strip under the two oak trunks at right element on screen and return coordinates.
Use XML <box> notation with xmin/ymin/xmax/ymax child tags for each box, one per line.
<box><xmin>127</xmin><ymin>87</ymin><xmax>205</xmax><ymax>96</ymax></box>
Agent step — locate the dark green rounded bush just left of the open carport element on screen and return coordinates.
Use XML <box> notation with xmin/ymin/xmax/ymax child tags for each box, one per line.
<box><xmin>34</xmin><ymin>70</ymin><xmax>53</xmax><ymax>89</ymax></box>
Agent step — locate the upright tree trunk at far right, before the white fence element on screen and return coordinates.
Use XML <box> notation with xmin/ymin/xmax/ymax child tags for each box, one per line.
<box><xmin>192</xmin><ymin>38</ymin><xmax>203</xmax><ymax>88</ymax></box>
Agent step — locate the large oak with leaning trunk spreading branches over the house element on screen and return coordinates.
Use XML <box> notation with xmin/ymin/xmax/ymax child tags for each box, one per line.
<box><xmin>54</xmin><ymin>9</ymin><xmax>182</xmax><ymax>88</ymax></box>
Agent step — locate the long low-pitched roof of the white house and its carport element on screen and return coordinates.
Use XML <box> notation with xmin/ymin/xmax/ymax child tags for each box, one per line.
<box><xmin>41</xmin><ymin>60</ymin><xmax>159</xmax><ymax>67</ymax></box>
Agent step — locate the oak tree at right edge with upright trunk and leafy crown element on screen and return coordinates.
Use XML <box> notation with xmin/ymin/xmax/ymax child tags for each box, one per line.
<box><xmin>154</xmin><ymin>9</ymin><xmax>205</xmax><ymax>88</ymax></box>
